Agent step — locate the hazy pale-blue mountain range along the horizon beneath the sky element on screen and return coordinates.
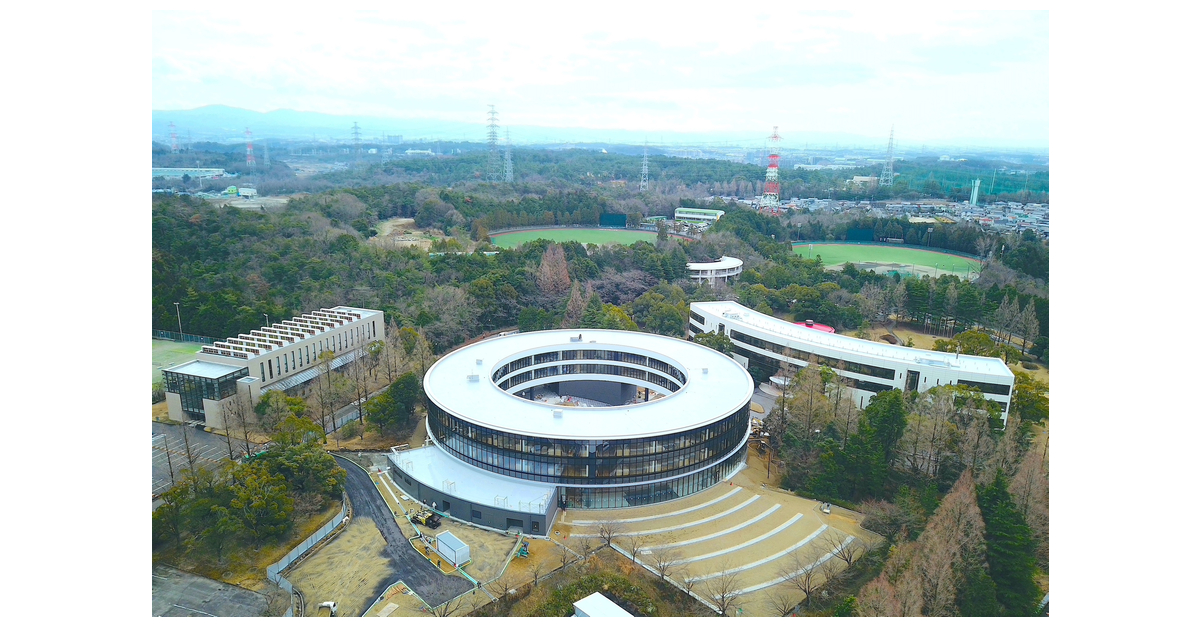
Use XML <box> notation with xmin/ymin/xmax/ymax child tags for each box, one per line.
<box><xmin>150</xmin><ymin>105</ymin><xmax>1045</xmax><ymax>154</ymax></box>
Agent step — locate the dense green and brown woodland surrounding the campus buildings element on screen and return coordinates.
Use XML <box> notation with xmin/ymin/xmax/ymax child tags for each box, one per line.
<box><xmin>151</xmin><ymin>156</ymin><xmax>1049</xmax><ymax>615</ymax></box>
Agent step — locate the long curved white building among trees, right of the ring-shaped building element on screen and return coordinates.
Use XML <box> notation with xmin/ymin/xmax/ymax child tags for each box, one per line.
<box><xmin>688</xmin><ymin>300</ymin><xmax>1015</xmax><ymax>424</ymax></box>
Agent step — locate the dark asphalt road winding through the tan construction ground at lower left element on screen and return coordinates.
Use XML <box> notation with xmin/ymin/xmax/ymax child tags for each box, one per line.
<box><xmin>335</xmin><ymin>455</ymin><xmax>473</xmax><ymax>607</ymax></box>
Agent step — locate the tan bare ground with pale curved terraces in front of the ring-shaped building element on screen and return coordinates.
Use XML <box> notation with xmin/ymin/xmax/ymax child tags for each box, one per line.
<box><xmin>287</xmin><ymin>449</ymin><xmax>877</xmax><ymax>616</ymax></box>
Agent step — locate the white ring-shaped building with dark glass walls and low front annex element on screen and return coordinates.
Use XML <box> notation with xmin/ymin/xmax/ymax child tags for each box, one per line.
<box><xmin>389</xmin><ymin>329</ymin><xmax>754</xmax><ymax>535</ymax></box>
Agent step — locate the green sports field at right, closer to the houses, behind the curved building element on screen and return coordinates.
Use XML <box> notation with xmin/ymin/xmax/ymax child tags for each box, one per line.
<box><xmin>792</xmin><ymin>243</ymin><xmax>979</xmax><ymax>277</ymax></box>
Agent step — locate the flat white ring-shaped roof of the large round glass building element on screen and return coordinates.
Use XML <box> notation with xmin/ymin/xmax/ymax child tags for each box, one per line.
<box><xmin>425</xmin><ymin>329</ymin><xmax>754</xmax><ymax>440</ymax></box>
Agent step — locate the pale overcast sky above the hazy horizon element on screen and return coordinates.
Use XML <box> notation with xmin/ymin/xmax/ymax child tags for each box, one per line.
<box><xmin>152</xmin><ymin>9</ymin><xmax>1050</xmax><ymax>148</ymax></box>
